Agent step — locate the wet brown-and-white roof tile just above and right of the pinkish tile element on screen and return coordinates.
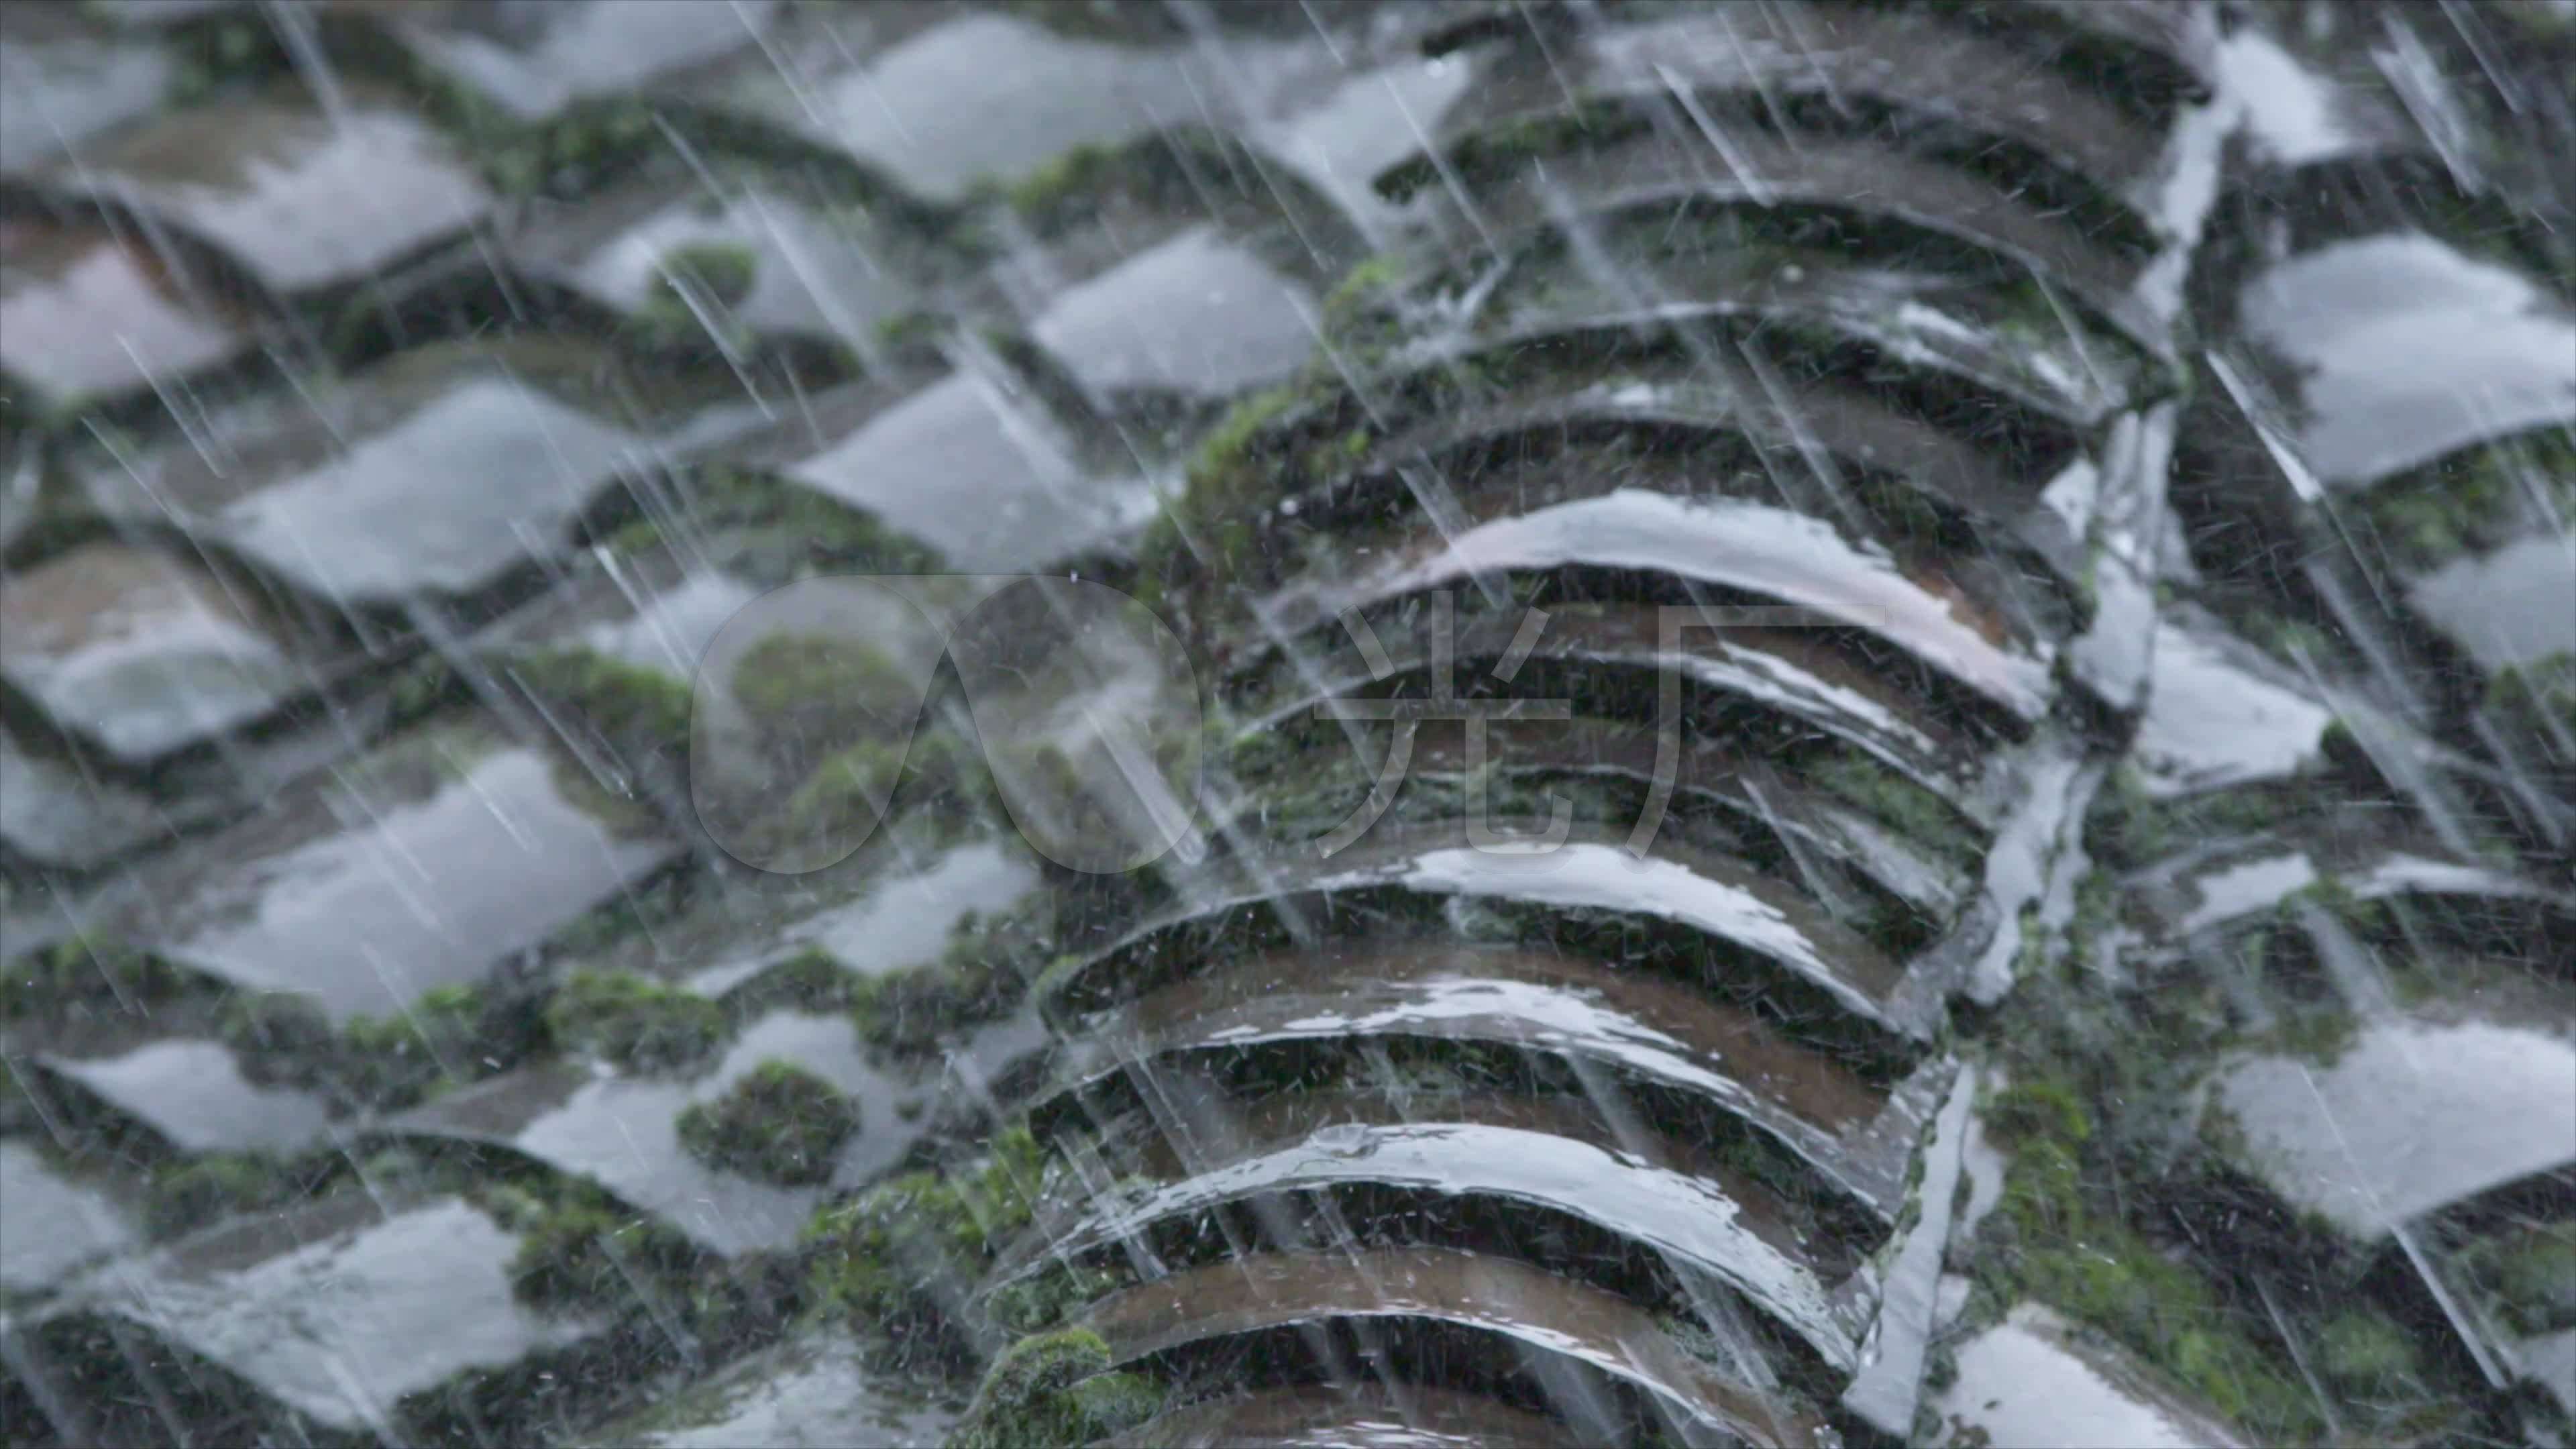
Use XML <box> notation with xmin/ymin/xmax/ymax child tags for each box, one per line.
<box><xmin>46</xmin><ymin>91</ymin><xmax>492</xmax><ymax>297</ymax></box>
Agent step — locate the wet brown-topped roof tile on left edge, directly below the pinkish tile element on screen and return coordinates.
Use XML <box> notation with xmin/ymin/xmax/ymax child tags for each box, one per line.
<box><xmin>0</xmin><ymin>541</ymin><xmax>309</xmax><ymax>761</ymax></box>
